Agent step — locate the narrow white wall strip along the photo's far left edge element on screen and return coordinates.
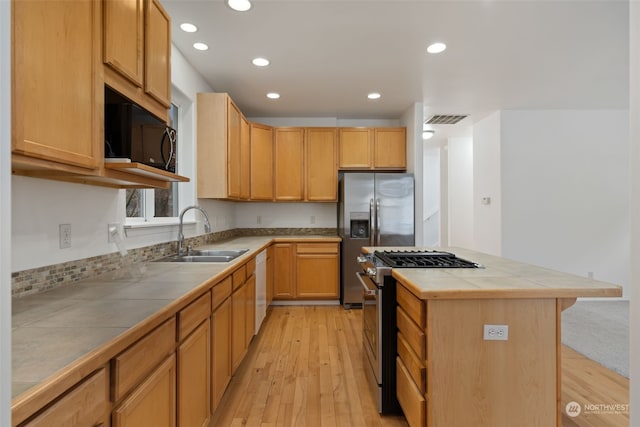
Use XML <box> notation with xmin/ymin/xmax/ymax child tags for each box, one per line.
<box><xmin>0</xmin><ymin>1</ymin><xmax>11</xmax><ymax>426</ymax></box>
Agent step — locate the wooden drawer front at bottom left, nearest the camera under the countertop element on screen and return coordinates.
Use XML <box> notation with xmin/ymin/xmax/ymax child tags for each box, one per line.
<box><xmin>23</xmin><ymin>368</ymin><xmax>109</xmax><ymax>427</ymax></box>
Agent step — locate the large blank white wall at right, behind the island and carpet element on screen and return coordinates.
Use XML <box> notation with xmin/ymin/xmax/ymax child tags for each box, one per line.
<box><xmin>500</xmin><ymin>110</ymin><xmax>630</xmax><ymax>296</ymax></box>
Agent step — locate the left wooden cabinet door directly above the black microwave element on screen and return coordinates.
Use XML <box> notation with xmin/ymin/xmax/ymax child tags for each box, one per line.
<box><xmin>103</xmin><ymin>0</ymin><xmax>144</xmax><ymax>87</ymax></box>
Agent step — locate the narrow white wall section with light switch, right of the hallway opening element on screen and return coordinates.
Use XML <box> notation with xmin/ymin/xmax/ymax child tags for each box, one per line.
<box><xmin>473</xmin><ymin>111</ymin><xmax>502</xmax><ymax>256</ymax></box>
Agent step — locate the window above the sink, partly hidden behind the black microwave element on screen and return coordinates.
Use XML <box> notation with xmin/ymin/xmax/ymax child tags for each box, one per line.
<box><xmin>126</xmin><ymin>104</ymin><xmax>180</xmax><ymax>223</ymax></box>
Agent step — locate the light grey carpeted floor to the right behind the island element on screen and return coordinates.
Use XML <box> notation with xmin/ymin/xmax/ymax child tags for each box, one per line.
<box><xmin>562</xmin><ymin>300</ymin><xmax>629</xmax><ymax>378</ymax></box>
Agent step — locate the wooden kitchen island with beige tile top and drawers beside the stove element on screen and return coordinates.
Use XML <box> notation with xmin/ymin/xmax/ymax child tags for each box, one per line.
<box><xmin>365</xmin><ymin>248</ymin><xmax>622</xmax><ymax>427</ymax></box>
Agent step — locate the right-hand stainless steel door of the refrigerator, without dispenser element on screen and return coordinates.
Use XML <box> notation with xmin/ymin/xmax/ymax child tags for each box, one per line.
<box><xmin>375</xmin><ymin>173</ymin><xmax>415</xmax><ymax>246</ymax></box>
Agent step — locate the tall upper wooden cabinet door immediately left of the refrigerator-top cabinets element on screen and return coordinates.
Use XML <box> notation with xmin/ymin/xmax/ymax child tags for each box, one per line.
<box><xmin>305</xmin><ymin>128</ymin><xmax>338</xmax><ymax>202</ymax></box>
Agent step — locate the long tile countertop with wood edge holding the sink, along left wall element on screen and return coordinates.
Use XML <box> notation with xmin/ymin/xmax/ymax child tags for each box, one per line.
<box><xmin>11</xmin><ymin>235</ymin><xmax>340</xmax><ymax>403</ymax></box>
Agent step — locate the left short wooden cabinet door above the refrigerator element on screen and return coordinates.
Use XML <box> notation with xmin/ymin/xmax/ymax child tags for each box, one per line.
<box><xmin>338</xmin><ymin>128</ymin><xmax>373</xmax><ymax>169</ymax></box>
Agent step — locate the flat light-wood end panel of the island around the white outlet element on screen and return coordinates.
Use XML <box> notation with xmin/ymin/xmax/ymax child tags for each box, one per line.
<box><xmin>426</xmin><ymin>299</ymin><xmax>559</xmax><ymax>427</ymax></box>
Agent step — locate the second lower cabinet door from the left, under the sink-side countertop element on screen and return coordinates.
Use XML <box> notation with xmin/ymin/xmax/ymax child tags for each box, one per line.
<box><xmin>178</xmin><ymin>318</ymin><xmax>211</xmax><ymax>427</ymax></box>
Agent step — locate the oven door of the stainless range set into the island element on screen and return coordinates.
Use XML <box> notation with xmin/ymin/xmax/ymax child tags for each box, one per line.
<box><xmin>357</xmin><ymin>273</ymin><xmax>382</xmax><ymax>385</ymax></box>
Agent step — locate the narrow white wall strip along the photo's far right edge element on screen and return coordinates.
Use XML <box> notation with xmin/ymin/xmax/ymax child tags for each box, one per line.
<box><xmin>629</xmin><ymin>2</ymin><xmax>640</xmax><ymax>426</ymax></box>
